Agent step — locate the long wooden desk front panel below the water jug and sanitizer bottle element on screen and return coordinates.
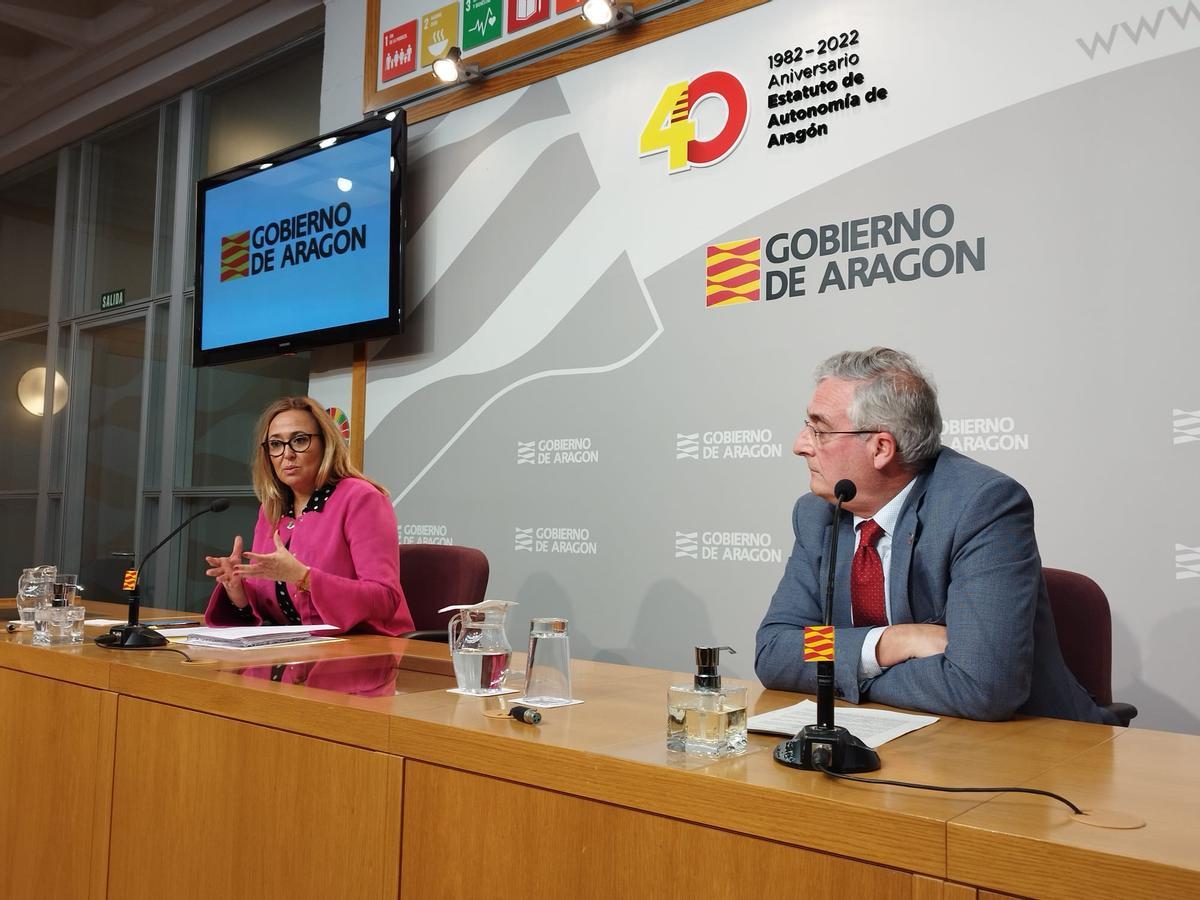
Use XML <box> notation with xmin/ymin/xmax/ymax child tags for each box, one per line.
<box><xmin>401</xmin><ymin>761</ymin><xmax>913</xmax><ymax>900</ymax></box>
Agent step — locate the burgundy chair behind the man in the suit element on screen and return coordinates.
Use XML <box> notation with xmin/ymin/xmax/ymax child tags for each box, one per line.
<box><xmin>1042</xmin><ymin>569</ymin><xmax>1138</xmax><ymax>725</ymax></box>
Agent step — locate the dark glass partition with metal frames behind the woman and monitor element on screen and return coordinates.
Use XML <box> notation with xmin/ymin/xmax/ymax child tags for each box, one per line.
<box><xmin>0</xmin><ymin>40</ymin><xmax>323</xmax><ymax>608</ymax></box>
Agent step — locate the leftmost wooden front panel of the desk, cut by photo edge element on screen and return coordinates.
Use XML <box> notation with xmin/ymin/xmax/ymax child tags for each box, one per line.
<box><xmin>0</xmin><ymin>668</ymin><xmax>116</xmax><ymax>900</ymax></box>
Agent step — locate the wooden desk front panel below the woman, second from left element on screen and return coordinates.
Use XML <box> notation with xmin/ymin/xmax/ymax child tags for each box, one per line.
<box><xmin>109</xmin><ymin>697</ymin><xmax>403</xmax><ymax>900</ymax></box>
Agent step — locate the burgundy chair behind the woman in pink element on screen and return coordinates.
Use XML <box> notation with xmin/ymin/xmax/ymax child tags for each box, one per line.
<box><xmin>400</xmin><ymin>544</ymin><xmax>488</xmax><ymax>642</ymax></box>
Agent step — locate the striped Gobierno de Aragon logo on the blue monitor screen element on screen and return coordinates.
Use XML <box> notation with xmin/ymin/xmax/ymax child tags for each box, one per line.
<box><xmin>221</xmin><ymin>200</ymin><xmax>367</xmax><ymax>282</ymax></box>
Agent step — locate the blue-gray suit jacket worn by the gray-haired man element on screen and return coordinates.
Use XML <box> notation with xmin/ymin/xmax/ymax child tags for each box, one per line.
<box><xmin>755</xmin><ymin>449</ymin><xmax>1117</xmax><ymax>725</ymax></box>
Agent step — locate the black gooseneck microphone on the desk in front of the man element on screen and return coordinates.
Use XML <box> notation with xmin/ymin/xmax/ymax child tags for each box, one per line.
<box><xmin>775</xmin><ymin>479</ymin><xmax>880</xmax><ymax>772</ymax></box>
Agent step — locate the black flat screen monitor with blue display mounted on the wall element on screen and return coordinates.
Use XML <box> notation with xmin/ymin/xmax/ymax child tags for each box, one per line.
<box><xmin>192</xmin><ymin>110</ymin><xmax>406</xmax><ymax>366</ymax></box>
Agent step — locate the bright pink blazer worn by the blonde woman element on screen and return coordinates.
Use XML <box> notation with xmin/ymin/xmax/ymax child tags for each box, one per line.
<box><xmin>204</xmin><ymin>478</ymin><xmax>413</xmax><ymax>635</ymax></box>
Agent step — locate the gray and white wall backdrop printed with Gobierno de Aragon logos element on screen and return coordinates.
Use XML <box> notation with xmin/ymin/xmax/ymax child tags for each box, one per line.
<box><xmin>312</xmin><ymin>0</ymin><xmax>1200</xmax><ymax>732</ymax></box>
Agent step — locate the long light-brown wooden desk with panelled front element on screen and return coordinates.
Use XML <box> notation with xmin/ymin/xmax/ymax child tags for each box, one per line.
<box><xmin>0</xmin><ymin>607</ymin><xmax>1200</xmax><ymax>900</ymax></box>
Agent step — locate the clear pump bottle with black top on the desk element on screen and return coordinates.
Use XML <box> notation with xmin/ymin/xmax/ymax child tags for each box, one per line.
<box><xmin>667</xmin><ymin>647</ymin><xmax>746</xmax><ymax>756</ymax></box>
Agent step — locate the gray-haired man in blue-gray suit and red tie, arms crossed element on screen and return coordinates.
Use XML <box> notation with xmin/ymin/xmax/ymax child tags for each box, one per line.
<box><xmin>755</xmin><ymin>347</ymin><xmax>1117</xmax><ymax>725</ymax></box>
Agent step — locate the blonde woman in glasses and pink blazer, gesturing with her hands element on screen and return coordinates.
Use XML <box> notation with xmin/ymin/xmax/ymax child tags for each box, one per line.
<box><xmin>204</xmin><ymin>397</ymin><xmax>413</xmax><ymax>635</ymax></box>
